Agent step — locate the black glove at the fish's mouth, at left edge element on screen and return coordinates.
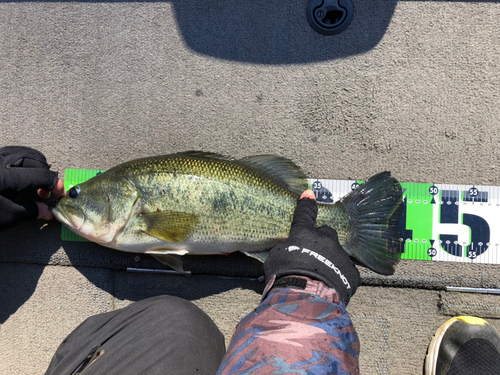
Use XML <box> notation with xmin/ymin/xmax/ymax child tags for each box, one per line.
<box><xmin>0</xmin><ymin>146</ymin><xmax>57</xmax><ymax>228</ymax></box>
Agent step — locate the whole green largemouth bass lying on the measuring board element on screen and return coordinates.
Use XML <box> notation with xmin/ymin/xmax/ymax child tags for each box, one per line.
<box><xmin>52</xmin><ymin>151</ymin><xmax>402</xmax><ymax>275</ymax></box>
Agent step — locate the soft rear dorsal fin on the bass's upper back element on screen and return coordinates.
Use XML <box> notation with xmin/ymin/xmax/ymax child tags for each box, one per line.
<box><xmin>238</xmin><ymin>155</ymin><xmax>308</xmax><ymax>194</ymax></box>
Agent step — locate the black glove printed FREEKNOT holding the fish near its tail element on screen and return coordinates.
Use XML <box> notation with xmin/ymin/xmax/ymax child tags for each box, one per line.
<box><xmin>264</xmin><ymin>198</ymin><xmax>361</xmax><ymax>305</ymax></box>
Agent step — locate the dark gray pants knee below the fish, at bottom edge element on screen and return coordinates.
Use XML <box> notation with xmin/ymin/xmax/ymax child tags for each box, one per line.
<box><xmin>46</xmin><ymin>296</ymin><xmax>225</xmax><ymax>375</ymax></box>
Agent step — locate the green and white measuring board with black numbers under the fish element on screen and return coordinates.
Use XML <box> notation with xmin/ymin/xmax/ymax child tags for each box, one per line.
<box><xmin>61</xmin><ymin>169</ymin><xmax>500</xmax><ymax>264</ymax></box>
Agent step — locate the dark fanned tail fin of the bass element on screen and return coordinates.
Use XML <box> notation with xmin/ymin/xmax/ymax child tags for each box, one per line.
<box><xmin>336</xmin><ymin>172</ymin><xmax>404</xmax><ymax>275</ymax></box>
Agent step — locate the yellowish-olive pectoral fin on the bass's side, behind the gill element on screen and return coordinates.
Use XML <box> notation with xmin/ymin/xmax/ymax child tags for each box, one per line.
<box><xmin>141</xmin><ymin>211</ymin><xmax>199</xmax><ymax>243</ymax></box>
